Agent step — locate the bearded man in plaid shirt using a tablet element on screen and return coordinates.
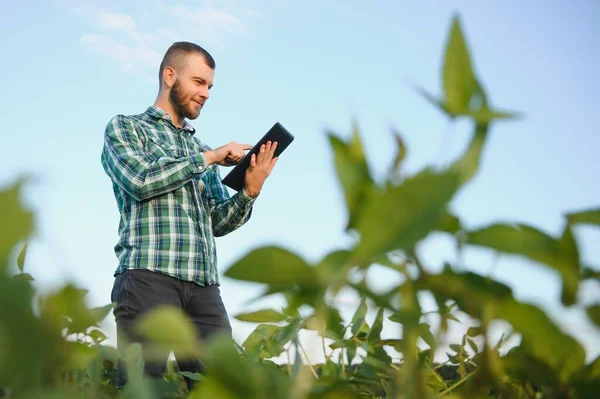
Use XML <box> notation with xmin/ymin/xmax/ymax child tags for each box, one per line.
<box><xmin>101</xmin><ymin>42</ymin><xmax>277</xmax><ymax>386</ymax></box>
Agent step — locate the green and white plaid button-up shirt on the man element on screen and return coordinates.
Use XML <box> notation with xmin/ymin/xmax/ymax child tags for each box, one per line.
<box><xmin>101</xmin><ymin>106</ymin><xmax>255</xmax><ymax>285</ymax></box>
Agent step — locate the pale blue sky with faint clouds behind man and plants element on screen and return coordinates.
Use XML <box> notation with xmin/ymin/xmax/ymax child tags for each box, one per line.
<box><xmin>0</xmin><ymin>0</ymin><xmax>600</xmax><ymax>360</ymax></box>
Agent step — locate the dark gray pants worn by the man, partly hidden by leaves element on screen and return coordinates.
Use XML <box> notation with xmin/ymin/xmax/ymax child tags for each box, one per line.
<box><xmin>111</xmin><ymin>269</ymin><xmax>231</xmax><ymax>388</ymax></box>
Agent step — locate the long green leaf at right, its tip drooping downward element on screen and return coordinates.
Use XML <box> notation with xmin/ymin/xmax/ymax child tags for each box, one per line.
<box><xmin>465</xmin><ymin>224</ymin><xmax>580</xmax><ymax>305</ymax></box>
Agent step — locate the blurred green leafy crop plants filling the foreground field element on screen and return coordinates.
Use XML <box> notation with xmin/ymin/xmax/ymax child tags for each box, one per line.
<box><xmin>0</xmin><ymin>17</ymin><xmax>600</xmax><ymax>398</ymax></box>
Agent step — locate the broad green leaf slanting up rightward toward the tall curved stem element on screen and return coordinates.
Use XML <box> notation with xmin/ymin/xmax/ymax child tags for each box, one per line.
<box><xmin>353</xmin><ymin>169</ymin><xmax>459</xmax><ymax>263</ymax></box>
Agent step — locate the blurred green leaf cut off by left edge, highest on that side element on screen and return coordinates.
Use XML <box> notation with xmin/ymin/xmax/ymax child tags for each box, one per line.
<box><xmin>0</xmin><ymin>179</ymin><xmax>34</xmax><ymax>273</ymax></box>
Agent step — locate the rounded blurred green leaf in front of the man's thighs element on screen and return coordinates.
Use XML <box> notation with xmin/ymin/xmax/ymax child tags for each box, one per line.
<box><xmin>135</xmin><ymin>305</ymin><xmax>199</xmax><ymax>356</ymax></box>
